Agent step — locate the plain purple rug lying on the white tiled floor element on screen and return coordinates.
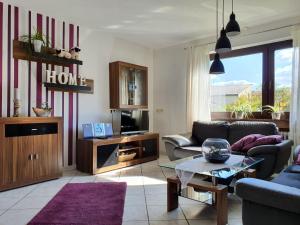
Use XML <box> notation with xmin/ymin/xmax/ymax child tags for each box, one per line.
<box><xmin>28</xmin><ymin>182</ymin><xmax>126</xmax><ymax>225</ymax></box>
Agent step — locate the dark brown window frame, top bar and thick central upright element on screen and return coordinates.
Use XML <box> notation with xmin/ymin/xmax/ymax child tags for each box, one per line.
<box><xmin>209</xmin><ymin>40</ymin><xmax>293</xmax><ymax>118</ymax></box>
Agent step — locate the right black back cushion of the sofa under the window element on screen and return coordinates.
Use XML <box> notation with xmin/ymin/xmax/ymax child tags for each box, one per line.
<box><xmin>228</xmin><ymin>121</ymin><xmax>278</xmax><ymax>144</ymax></box>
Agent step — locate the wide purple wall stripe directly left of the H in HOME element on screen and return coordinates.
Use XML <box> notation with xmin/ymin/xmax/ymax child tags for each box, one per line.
<box><xmin>36</xmin><ymin>14</ymin><xmax>43</xmax><ymax>107</ymax></box>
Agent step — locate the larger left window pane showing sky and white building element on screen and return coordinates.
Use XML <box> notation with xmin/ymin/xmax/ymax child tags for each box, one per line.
<box><xmin>211</xmin><ymin>53</ymin><xmax>262</xmax><ymax>112</ymax></box>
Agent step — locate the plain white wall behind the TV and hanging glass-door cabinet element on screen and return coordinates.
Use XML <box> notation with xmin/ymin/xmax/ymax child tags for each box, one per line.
<box><xmin>79</xmin><ymin>28</ymin><xmax>153</xmax><ymax>135</ymax></box>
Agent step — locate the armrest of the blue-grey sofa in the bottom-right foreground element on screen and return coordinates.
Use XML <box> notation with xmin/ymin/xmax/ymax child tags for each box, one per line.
<box><xmin>236</xmin><ymin>178</ymin><xmax>300</xmax><ymax>214</ymax></box>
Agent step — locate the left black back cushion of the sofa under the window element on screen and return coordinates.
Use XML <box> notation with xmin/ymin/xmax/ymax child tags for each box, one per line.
<box><xmin>192</xmin><ymin>121</ymin><xmax>229</xmax><ymax>145</ymax></box>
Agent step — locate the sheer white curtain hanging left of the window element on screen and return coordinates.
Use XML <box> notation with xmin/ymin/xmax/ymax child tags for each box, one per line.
<box><xmin>187</xmin><ymin>46</ymin><xmax>211</xmax><ymax>131</ymax></box>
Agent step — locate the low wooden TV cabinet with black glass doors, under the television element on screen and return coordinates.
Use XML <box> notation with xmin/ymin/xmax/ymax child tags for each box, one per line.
<box><xmin>76</xmin><ymin>133</ymin><xmax>159</xmax><ymax>174</ymax></box>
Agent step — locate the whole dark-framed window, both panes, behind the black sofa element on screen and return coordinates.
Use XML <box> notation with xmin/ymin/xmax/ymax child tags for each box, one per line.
<box><xmin>210</xmin><ymin>40</ymin><xmax>292</xmax><ymax>117</ymax></box>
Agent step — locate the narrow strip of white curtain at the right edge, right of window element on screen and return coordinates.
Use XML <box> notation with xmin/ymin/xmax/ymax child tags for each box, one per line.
<box><xmin>289</xmin><ymin>26</ymin><xmax>300</xmax><ymax>155</ymax></box>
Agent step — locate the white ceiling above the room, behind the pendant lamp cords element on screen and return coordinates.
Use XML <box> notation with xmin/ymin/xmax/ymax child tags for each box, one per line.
<box><xmin>9</xmin><ymin>0</ymin><xmax>300</xmax><ymax>48</ymax></box>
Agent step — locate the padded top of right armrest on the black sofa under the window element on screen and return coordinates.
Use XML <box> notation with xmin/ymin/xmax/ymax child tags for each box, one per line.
<box><xmin>247</xmin><ymin>140</ymin><xmax>293</xmax><ymax>156</ymax></box>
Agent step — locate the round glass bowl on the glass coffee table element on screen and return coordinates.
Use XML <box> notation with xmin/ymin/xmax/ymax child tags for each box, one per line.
<box><xmin>202</xmin><ymin>138</ymin><xmax>231</xmax><ymax>163</ymax></box>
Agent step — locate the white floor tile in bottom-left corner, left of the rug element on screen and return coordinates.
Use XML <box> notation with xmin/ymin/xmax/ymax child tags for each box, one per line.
<box><xmin>0</xmin><ymin>209</ymin><xmax>39</xmax><ymax>225</ymax></box>
